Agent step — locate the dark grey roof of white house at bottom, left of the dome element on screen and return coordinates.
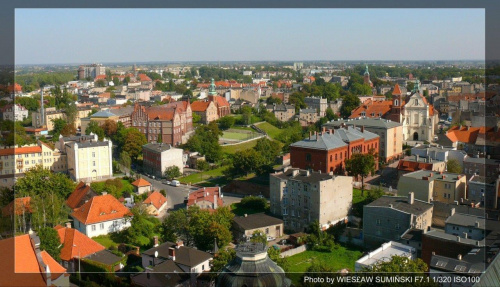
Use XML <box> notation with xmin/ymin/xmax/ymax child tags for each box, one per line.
<box><xmin>143</xmin><ymin>242</ymin><xmax>212</xmax><ymax>267</ymax></box>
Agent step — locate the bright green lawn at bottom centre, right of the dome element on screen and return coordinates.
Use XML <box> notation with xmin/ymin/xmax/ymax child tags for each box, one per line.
<box><xmin>287</xmin><ymin>248</ymin><xmax>363</xmax><ymax>286</ymax></box>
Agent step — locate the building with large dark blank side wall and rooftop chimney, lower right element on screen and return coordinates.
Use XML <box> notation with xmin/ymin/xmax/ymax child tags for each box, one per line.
<box><xmin>363</xmin><ymin>192</ymin><xmax>432</xmax><ymax>250</ymax></box>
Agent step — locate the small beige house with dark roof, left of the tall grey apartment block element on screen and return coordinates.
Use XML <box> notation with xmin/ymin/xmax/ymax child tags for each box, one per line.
<box><xmin>233</xmin><ymin>213</ymin><xmax>284</xmax><ymax>241</ymax></box>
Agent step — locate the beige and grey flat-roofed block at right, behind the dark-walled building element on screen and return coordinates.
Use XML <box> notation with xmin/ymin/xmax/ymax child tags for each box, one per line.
<box><xmin>398</xmin><ymin>170</ymin><xmax>467</xmax><ymax>203</ymax></box>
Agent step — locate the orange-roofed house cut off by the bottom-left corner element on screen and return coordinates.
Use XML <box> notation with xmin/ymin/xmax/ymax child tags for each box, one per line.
<box><xmin>0</xmin><ymin>233</ymin><xmax>70</xmax><ymax>287</ymax></box>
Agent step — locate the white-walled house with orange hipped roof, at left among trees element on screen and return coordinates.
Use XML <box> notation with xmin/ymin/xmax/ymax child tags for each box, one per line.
<box><xmin>70</xmin><ymin>192</ymin><xmax>132</xmax><ymax>237</ymax></box>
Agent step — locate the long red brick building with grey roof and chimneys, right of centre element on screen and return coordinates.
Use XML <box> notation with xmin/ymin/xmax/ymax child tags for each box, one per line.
<box><xmin>290</xmin><ymin>126</ymin><xmax>380</xmax><ymax>173</ymax></box>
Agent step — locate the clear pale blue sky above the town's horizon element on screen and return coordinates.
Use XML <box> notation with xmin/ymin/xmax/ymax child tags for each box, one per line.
<box><xmin>15</xmin><ymin>9</ymin><xmax>485</xmax><ymax>65</ymax></box>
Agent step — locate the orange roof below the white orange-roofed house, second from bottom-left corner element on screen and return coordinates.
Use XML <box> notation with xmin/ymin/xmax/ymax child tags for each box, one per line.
<box><xmin>56</xmin><ymin>227</ymin><xmax>106</xmax><ymax>261</ymax></box>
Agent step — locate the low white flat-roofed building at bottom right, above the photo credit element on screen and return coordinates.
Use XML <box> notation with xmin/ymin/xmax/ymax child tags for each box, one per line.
<box><xmin>354</xmin><ymin>241</ymin><xmax>417</xmax><ymax>272</ymax></box>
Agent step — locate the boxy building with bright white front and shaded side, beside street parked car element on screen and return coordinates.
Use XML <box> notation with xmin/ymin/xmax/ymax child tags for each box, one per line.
<box><xmin>142</xmin><ymin>143</ymin><xmax>184</xmax><ymax>177</ymax></box>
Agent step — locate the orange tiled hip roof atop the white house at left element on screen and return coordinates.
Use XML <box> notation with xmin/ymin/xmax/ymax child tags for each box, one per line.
<box><xmin>71</xmin><ymin>194</ymin><xmax>132</xmax><ymax>224</ymax></box>
